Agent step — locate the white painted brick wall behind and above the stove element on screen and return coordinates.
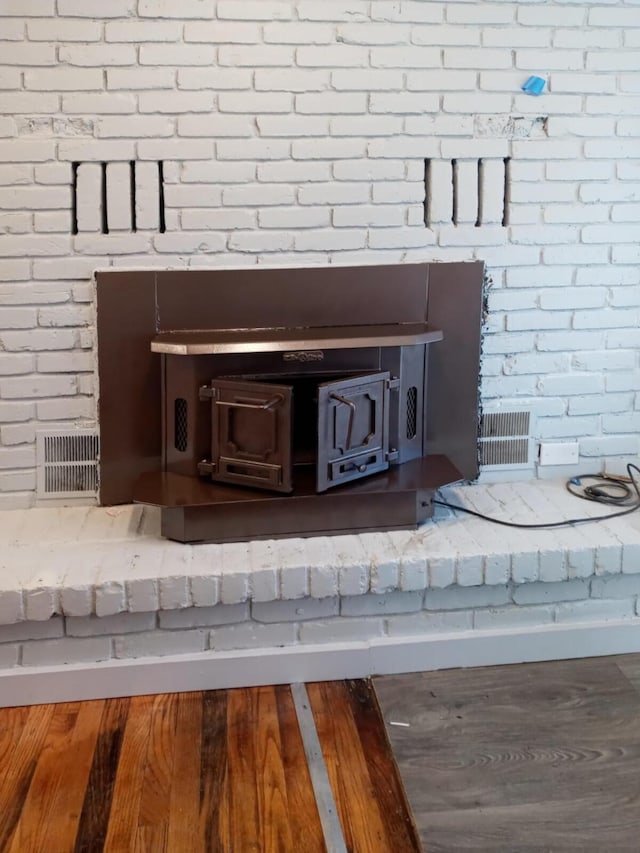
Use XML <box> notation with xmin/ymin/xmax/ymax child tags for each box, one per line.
<box><xmin>0</xmin><ymin>0</ymin><xmax>640</xmax><ymax>500</ymax></box>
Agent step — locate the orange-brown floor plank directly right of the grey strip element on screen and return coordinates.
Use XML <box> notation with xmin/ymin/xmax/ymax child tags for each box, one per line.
<box><xmin>307</xmin><ymin>682</ymin><xmax>393</xmax><ymax>853</ymax></box>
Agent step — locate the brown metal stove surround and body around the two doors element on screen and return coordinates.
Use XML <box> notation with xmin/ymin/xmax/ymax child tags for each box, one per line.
<box><xmin>96</xmin><ymin>262</ymin><xmax>484</xmax><ymax>542</ymax></box>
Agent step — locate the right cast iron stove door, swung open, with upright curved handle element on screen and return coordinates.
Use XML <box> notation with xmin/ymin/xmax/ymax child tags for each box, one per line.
<box><xmin>317</xmin><ymin>372</ymin><xmax>390</xmax><ymax>492</ymax></box>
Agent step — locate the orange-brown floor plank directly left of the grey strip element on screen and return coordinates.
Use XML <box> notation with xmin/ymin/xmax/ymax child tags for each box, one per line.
<box><xmin>275</xmin><ymin>685</ymin><xmax>326</xmax><ymax>853</ymax></box>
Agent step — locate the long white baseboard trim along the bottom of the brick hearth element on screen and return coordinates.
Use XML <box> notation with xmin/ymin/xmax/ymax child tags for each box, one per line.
<box><xmin>5</xmin><ymin>620</ymin><xmax>640</xmax><ymax>707</ymax></box>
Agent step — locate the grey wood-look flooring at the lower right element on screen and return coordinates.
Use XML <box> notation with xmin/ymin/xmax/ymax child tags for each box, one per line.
<box><xmin>374</xmin><ymin>655</ymin><xmax>640</xmax><ymax>853</ymax></box>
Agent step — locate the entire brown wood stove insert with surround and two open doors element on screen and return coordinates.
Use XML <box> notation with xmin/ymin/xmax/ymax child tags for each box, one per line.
<box><xmin>97</xmin><ymin>263</ymin><xmax>483</xmax><ymax>542</ymax></box>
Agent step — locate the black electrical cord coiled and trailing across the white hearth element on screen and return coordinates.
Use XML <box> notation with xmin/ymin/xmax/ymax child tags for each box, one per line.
<box><xmin>433</xmin><ymin>462</ymin><xmax>640</xmax><ymax>530</ymax></box>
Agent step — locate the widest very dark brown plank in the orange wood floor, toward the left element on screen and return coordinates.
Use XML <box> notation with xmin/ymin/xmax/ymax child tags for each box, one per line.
<box><xmin>75</xmin><ymin>698</ymin><xmax>130</xmax><ymax>853</ymax></box>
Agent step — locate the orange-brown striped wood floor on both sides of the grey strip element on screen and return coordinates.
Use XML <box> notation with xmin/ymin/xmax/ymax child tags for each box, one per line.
<box><xmin>0</xmin><ymin>681</ymin><xmax>420</xmax><ymax>853</ymax></box>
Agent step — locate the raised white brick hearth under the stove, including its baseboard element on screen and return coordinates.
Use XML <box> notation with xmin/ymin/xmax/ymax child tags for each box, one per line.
<box><xmin>0</xmin><ymin>481</ymin><xmax>640</xmax><ymax>705</ymax></box>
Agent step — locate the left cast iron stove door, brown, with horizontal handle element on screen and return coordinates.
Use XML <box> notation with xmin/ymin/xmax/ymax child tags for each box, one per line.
<box><xmin>205</xmin><ymin>379</ymin><xmax>293</xmax><ymax>492</ymax></box>
